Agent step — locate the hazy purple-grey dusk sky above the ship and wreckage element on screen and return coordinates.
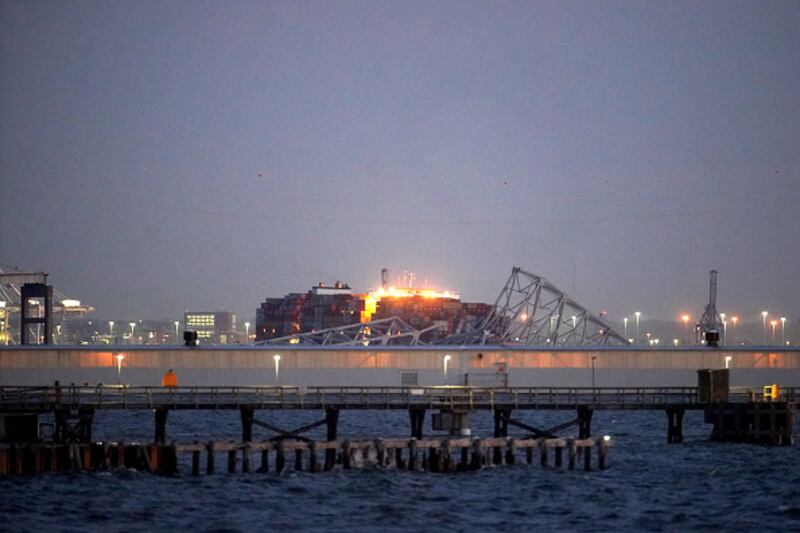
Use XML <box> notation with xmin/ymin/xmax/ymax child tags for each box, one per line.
<box><xmin>0</xmin><ymin>0</ymin><xmax>800</xmax><ymax>321</ymax></box>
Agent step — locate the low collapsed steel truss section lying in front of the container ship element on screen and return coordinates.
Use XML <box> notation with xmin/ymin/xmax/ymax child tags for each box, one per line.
<box><xmin>256</xmin><ymin>317</ymin><xmax>439</xmax><ymax>346</ymax></box>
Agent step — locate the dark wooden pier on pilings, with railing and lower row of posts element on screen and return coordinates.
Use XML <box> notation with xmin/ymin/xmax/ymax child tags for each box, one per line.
<box><xmin>0</xmin><ymin>382</ymin><xmax>800</xmax><ymax>474</ymax></box>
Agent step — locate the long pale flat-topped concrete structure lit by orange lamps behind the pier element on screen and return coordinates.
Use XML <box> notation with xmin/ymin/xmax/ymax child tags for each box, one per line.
<box><xmin>0</xmin><ymin>346</ymin><xmax>800</xmax><ymax>388</ymax></box>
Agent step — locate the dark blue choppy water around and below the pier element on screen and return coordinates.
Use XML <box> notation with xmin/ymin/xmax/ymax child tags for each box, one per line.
<box><xmin>0</xmin><ymin>411</ymin><xmax>800</xmax><ymax>532</ymax></box>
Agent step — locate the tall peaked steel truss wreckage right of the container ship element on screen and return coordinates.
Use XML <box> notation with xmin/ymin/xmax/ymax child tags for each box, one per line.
<box><xmin>443</xmin><ymin>267</ymin><xmax>629</xmax><ymax>346</ymax></box>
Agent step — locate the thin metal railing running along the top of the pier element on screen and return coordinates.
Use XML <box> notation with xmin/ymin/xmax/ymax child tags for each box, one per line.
<box><xmin>0</xmin><ymin>385</ymin><xmax>748</xmax><ymax>412</ymax></box>
